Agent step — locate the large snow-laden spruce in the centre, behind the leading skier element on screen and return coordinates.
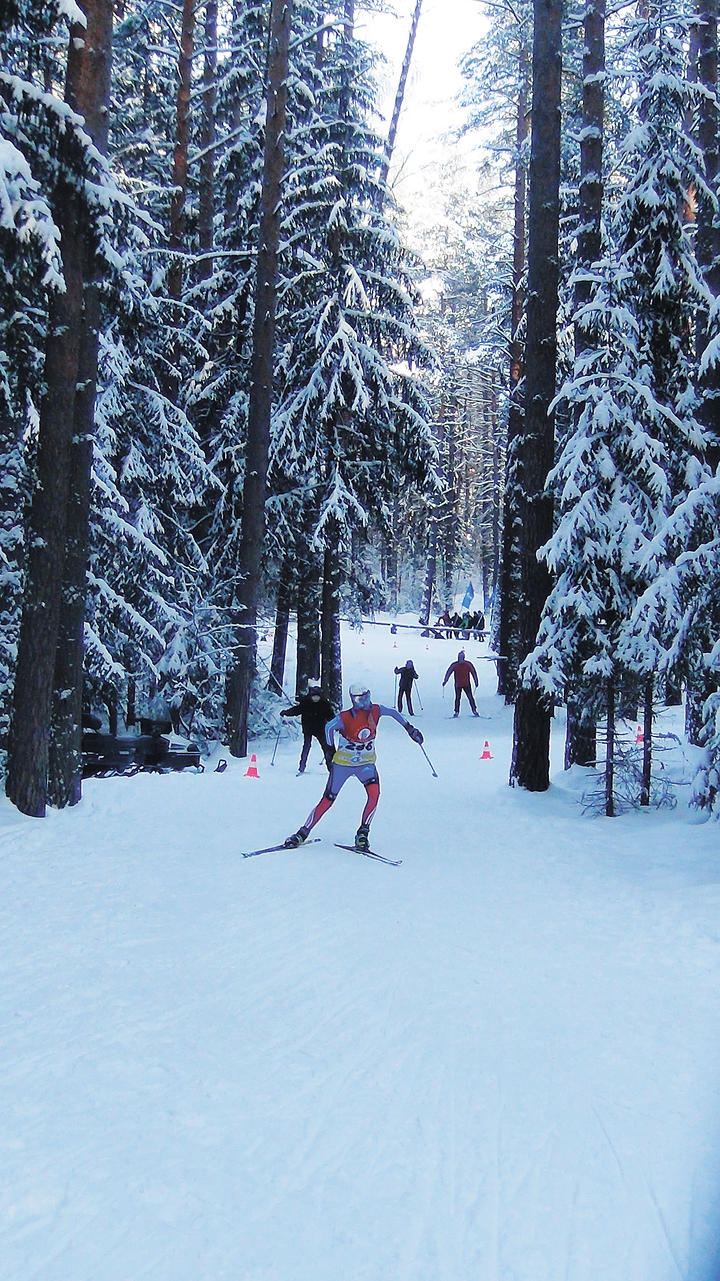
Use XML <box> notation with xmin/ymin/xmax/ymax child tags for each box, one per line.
<box><xmin>272</xmin><ymin>0</ymin><xmax>436</xmax><ymax>692</ymax></box>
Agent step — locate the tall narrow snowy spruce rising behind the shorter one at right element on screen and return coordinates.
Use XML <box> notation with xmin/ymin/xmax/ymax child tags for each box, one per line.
<box><xmin>607</xmin><ymin>5</ymin><xmax>712</xmax><ymax>748</ymax></box>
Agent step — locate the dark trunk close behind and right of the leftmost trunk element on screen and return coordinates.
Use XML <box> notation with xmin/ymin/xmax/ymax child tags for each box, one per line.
<box><xmin>47</xmin><ymin>0</ymin><xmax>113</xmax><ymax>808</ymax></box>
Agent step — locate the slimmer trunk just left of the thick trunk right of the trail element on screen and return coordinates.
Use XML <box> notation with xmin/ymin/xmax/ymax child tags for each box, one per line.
<box><xmin>497</xmin><ymin>44</ymin><xmax>530</xmax><ymax>702</ymax></box>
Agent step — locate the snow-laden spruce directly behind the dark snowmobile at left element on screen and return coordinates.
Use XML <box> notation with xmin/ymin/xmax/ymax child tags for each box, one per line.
<box><xmin>86</xmin><ymin>280</ymin><xmax>219</xmax><ymax>739</ymax></box>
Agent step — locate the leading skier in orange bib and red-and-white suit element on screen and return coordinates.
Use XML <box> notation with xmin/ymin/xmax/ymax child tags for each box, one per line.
<box><xmin>286</xmin><ymin>684</ymin><xmax>423</xmax><ymax>849</ymax></box>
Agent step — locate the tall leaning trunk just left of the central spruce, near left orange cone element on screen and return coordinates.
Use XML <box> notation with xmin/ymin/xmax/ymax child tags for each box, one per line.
<box><xmin>225</xmin><ymin>0</ymin><xmax>292</xmax><ymax>756</ymax></box>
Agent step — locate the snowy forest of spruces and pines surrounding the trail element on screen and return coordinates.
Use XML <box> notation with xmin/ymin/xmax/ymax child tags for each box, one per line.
<box><xmin>0</xmin><ymin>0</ymin><xmax>720</xmax><ymax>815</ymax></box>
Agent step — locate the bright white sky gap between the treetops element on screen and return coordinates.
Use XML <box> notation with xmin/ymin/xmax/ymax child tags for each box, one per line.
<box><xmin>357</xmin><ymin>0</ymin><xmax>486</xmax><ymax>204</ymax></box>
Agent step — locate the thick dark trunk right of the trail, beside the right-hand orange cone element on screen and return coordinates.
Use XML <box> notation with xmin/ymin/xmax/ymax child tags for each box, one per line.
<box><xmin>510</xmin><ymin>0</ymin><xmax>562</xmax><ymax>792</ymax></box>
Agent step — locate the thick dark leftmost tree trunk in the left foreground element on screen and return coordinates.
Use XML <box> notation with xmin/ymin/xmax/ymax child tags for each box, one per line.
<box><xmin>6</xmin><ymin>0</ymin><xmax>111</xmax><ymax>817</ymax></box>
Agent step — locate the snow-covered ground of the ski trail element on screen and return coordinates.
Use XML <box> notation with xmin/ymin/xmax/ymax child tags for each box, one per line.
<box><xmin>0</xmin><ymin>617</ymin><xmax>720</xmax><ymax>1281</ymax></box>
